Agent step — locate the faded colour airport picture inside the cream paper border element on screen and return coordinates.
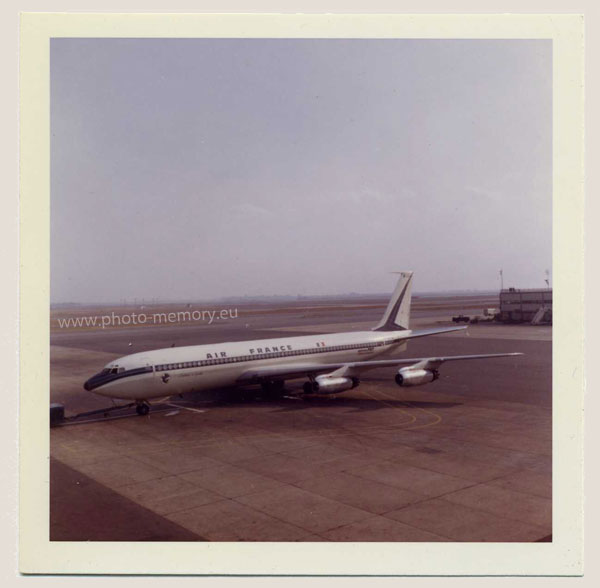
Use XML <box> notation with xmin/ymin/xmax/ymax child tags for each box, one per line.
<box><xmin>49</xmin><ymin>37</ymin><xmax>553</xmax><ymax>543</ymax></box>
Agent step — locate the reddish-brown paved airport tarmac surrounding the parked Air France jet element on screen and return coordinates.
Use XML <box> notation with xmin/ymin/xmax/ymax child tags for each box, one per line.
<box><xmin>50</xmin><ymin>300</ymin><xmax>552</xmax><ymax>542</ymax></box>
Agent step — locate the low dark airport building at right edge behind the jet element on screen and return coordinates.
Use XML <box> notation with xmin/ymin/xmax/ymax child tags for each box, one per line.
<box><xmin>498</xmin><ymin>288</ymin><xmax>552</xmax><ymax>324</ymax></box>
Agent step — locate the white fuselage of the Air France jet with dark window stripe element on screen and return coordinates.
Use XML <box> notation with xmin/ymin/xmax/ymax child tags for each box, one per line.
<box><xmin>84</xmin><ymin>330</ymin><xmax>411</xmax><ymax>400</ymax></box>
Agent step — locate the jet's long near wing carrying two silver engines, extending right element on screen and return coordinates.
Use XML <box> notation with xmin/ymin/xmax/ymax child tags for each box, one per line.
<box><xmin>237</xmin><ymin>353</ymin><xmax>523</xmax><ymax>384</ymax></box>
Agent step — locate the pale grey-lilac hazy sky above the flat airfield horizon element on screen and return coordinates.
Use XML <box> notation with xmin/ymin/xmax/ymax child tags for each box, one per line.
<box><xmin>51</xmin><ymin>39</ymin><xmax>552</xmax><ymax>302</ymax></box>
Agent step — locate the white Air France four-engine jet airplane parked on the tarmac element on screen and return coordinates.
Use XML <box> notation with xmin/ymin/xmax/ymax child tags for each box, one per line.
<box><xmin>84</xmin><ymin>271</ymin><xmax>522</xmax><ymax>415</ymax></box>
